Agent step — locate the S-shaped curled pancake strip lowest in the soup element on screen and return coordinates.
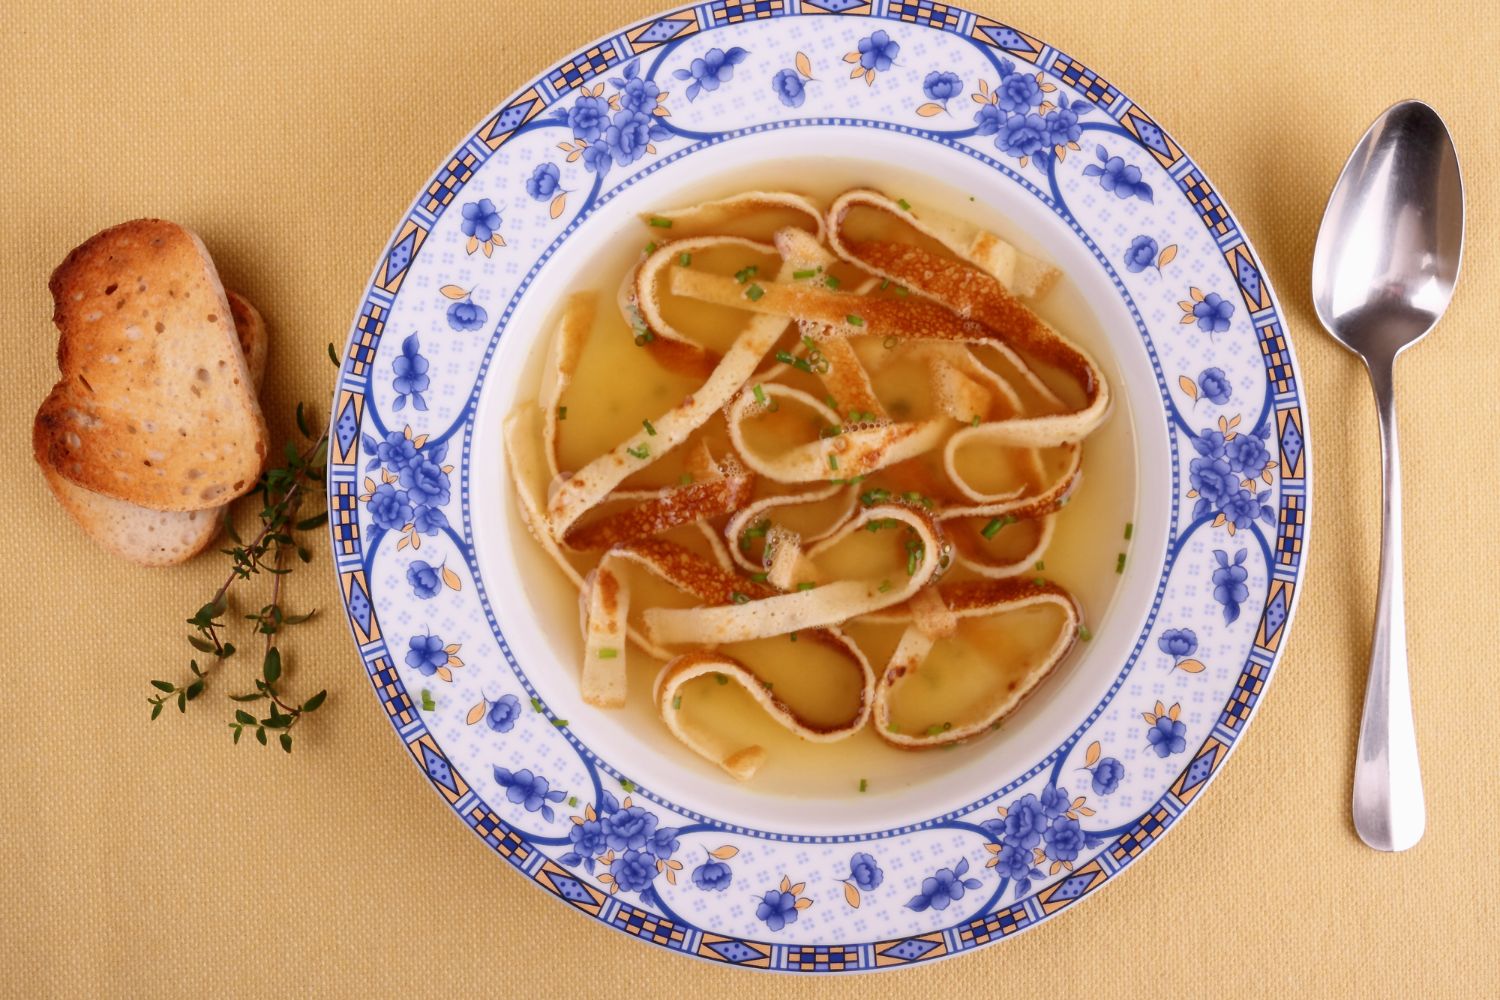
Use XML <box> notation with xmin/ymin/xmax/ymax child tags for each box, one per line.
<box><xmin>654</xmin><ymin>628</ymin><xmax>876</xmax><ymax>781</ymax></box>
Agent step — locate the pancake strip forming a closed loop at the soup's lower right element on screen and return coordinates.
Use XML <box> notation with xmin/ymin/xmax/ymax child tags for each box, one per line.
<box><xmin>873</xmin><ymin>580</ymin><xmax>1083</xmax><ymax>750</ymax></box>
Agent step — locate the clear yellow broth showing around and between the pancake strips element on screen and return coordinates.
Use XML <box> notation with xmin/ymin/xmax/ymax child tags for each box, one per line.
<box><xmin>512</xmin><ymin>159</ymin><xmax>1136</xmax><ymax>799</ymax></box>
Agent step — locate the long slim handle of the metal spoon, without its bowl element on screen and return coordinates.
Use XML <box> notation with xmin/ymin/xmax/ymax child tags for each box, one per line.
<box><xmin>1355</xmin><ymin>358</ymin><xmax>1427</xmax><ymax>850</ymax></box>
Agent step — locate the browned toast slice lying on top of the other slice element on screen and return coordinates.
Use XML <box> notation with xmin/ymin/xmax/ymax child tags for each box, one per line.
<box><xmin>32</xmin><ymin>219</ymin><xmax>269</xmax><ymax>511</ymax></box>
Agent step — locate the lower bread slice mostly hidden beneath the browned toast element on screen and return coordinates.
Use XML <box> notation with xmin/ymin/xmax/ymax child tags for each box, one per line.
<box><xmin>42</xmin><ymin>291</ymin><xmax>270</xmax><ymax>567</ymax></box>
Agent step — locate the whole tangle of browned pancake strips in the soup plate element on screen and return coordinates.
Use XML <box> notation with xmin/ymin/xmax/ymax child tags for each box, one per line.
<box><xmin>506</xmin><ymin>190</ymin><xmax>1110</xmax><ymax>780</ymax></box>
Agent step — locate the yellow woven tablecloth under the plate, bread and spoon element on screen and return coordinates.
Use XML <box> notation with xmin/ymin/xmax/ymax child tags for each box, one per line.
<box><xmin>0</xmin><ymin>0</ymin><xmax>1500</xmax><ymax>997</ymax></box>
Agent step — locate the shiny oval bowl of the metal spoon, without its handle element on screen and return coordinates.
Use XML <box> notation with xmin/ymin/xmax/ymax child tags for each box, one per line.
<box><xmin>1313</xmin><ymin>100</ymin><xmax>1464</xmax><ymax>358</ymax></box>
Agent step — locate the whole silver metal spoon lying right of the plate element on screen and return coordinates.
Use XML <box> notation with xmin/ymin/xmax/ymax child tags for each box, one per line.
<box><xmin>1313</xmin><ymin>100</ymin><xmax>1464</xmax><ymax>850</ymax></box>
